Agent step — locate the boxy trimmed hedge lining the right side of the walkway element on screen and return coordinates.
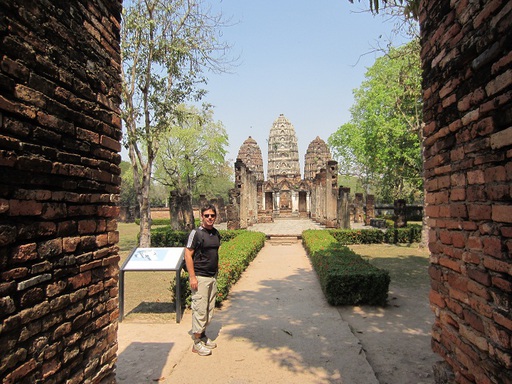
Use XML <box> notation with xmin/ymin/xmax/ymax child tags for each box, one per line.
<box><xmin>302</xmin><ymin>230</ymin><xmax>390</xmax><ymax>305</ymax></box>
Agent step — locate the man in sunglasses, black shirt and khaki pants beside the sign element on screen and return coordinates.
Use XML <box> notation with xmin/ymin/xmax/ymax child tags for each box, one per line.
<box><xmin>185</xmin><ymin>204</ymin><xmax>220</xmax><ymax>356</ymax></box>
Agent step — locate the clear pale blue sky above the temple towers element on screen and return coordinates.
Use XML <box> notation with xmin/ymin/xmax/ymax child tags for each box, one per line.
<box><xmin>203</xmin><ymin>0</ymin><xmax>412</xmax><ymax>172</ymax></box>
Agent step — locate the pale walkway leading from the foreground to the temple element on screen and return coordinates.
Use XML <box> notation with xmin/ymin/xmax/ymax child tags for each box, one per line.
<box><xmin>117</xmin><ymin>220</ymin><xmax>378</xmax><ymax>384</ymax></box>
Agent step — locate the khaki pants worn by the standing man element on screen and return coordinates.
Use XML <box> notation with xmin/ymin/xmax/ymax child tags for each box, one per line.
<box><xmin>192</xmin><ymin>276</ymin><xmax>217</xmax><ymax>333</ymax></box>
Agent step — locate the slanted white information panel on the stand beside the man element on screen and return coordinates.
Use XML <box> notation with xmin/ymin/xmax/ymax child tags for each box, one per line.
<box><xmin>121</xmin><ymin>247</ymin><xmax>185</xmax><ymax>271</ymax></box>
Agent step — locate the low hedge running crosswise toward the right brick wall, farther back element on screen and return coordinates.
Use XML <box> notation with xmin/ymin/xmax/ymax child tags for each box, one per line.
<box><xmin>329</xmin><ymin>224</ymin><xmax>421</xmax><ymax>245</ymax></box>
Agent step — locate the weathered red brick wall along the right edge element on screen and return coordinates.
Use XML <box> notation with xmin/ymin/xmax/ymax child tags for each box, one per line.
<box><xmin>420</xmin><ymin>0</ymin><xmax>512</xmax><ymax>383</ymax></box>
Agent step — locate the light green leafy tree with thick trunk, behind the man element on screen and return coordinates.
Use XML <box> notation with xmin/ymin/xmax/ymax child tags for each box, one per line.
<box><xmin>155</xmin><ymin>106</ymin><xmax>228</xmax><ymax>230</ymax></box>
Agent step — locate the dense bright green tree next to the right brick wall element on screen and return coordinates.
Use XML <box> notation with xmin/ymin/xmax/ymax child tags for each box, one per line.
<box><xmin>328</xmin><ymin>40</ymin><xmax>423</xmax><ymax>201</ymax></box>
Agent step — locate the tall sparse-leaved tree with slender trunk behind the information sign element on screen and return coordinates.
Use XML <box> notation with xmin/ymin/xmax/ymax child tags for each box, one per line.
<box><xmin>121</xmin><ymin>0</ymin><xmax>229</xmax><ymax>247</ymax></box>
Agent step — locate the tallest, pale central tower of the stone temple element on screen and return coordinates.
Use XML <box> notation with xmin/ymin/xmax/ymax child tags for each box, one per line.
<box><xmin>267</xmin><ymin>114</ymin><xmax>301</xmax><ymax>183</ymax></box>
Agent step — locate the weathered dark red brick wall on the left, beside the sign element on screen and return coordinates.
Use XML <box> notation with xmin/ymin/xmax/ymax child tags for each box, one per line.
<box><xmin>0</xmin><ymin>0</ymin><xmax>121</xmax><ymax>383</ymax></box>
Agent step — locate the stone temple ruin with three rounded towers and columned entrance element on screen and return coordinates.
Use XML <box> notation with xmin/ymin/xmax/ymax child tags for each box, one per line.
<box><xmin>227</xmin><ymin>114</ymin><xmax>344</xmax><ymax>229</ymax></box>
